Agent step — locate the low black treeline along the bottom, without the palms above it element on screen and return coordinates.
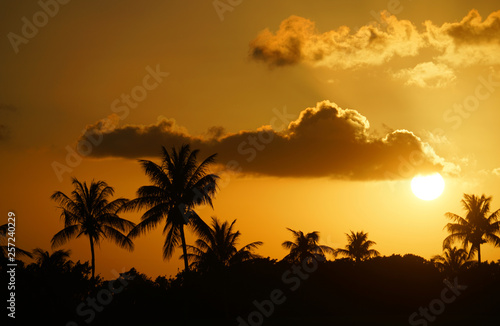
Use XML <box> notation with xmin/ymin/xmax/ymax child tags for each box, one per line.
<box><xmin>1</xmin><ymin>255</ymin><xmax>500</xmax><ymax>325</ymax></box>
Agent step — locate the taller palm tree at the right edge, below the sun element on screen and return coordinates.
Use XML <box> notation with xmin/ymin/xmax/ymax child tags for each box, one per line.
<box><xmin>443</xmin><ymin>194</ymin><xmax>500</xmax><ymax>264</ymax></box>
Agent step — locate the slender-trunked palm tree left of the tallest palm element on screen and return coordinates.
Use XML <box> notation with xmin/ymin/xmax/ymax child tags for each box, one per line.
<box><xmin>50</xmin><ymin>178</ymin><xmax>135</xmax><ymax>280</ymax></box>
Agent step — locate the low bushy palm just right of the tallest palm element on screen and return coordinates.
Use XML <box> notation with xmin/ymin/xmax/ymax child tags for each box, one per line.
<box><xmin>183</xmin><ymin>217</ymin><xmax>262</xmax><ymax>271</ymax></box>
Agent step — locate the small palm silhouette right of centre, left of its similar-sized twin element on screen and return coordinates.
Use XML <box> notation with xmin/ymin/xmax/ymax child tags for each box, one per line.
<box><xmin>281</xmin><ymin>228</ymin><xmax>335</xmax><ymax>263</ymax></box>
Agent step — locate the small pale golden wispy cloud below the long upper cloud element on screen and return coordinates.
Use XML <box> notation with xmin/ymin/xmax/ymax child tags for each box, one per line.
<box><xmin>394</xmin><ymin>62</ymin><xmax>457</xmax><ymax>88</ymax></box>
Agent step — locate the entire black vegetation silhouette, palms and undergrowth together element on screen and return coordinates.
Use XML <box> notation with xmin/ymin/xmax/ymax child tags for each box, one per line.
<box><xmin>0</xmin><ymin>145</ymin><xmax>500</xmax><ymax>326</ymax></box>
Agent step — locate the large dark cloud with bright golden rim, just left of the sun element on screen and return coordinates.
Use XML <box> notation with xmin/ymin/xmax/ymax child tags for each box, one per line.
<box><xmin>79</xmin><ymin>101</ymin><xmax>458</xmax><ymax>180</ymax></box>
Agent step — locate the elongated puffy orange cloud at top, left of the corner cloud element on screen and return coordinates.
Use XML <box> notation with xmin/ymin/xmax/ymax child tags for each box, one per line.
<box><xmin>250</xmin><ymin>12</ymin><xmax>425</xmax><ymax>69</ymax></box>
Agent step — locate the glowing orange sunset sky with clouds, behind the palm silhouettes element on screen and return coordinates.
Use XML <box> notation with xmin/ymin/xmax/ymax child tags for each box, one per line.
<box><xmin>0</xmin><ymin>0</ymin><xmax>500</xmax><ymax>278</ymax></box>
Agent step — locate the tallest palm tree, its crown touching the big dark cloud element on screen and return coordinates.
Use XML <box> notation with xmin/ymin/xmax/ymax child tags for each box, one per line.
<box><xmin>126</xmin><ymin>145</ymin><xmax>219</xmax><ymax>271</ymax></box>
